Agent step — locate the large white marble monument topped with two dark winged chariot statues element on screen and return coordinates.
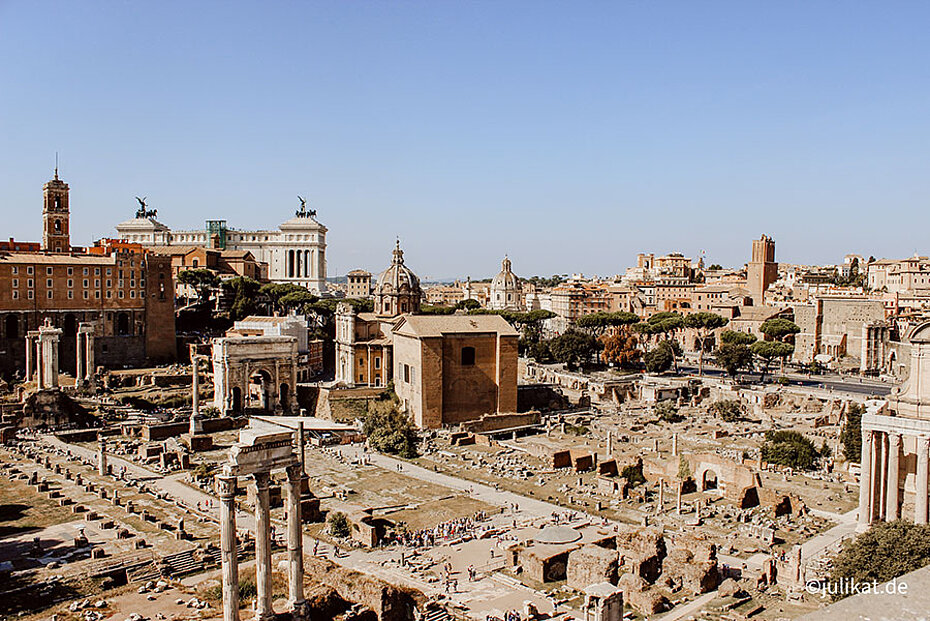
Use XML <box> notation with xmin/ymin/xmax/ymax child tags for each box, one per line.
<box><xmin>116</xmin><ymin>203</ymin><xmax>327</xmax><ymax>295</ymax></box>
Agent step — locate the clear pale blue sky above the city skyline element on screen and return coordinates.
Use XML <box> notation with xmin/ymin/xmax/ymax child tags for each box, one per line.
<box><xmin>0</xmin><ymin>0</ymin><xmax>930</xmax><ymax>278</ymax></box>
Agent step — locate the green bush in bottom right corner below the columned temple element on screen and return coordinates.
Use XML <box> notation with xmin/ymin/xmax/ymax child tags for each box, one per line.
<box><xmin>830</xmin><ymin>520</ymin><xmax>930</xmax><ymax>600</ymax></box>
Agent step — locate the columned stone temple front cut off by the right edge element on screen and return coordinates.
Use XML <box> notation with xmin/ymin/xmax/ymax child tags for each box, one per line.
<box><xmin>859</xmin><ymin>322</ymin><xmax>930</xmax><ymax>530</ymax></box>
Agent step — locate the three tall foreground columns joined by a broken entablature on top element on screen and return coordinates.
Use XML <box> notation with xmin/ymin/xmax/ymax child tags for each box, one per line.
<box><xmin>216</xmin><ymin>421</ymin><xmax>306</xmax><ymax>621</ymax></box>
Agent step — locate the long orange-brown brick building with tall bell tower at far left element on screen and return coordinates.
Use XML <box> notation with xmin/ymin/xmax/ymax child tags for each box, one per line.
<box><xmin>0</xmin><ymin>170</ymin><xmax>176</xmax><ymax>376</ymax></box>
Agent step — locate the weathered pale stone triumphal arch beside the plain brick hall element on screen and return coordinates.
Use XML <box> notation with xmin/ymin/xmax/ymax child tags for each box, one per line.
<box><xmin>213</xmin><ymin>336</ymin><xmax>297</xmax><ymax>415</ymax></box>
